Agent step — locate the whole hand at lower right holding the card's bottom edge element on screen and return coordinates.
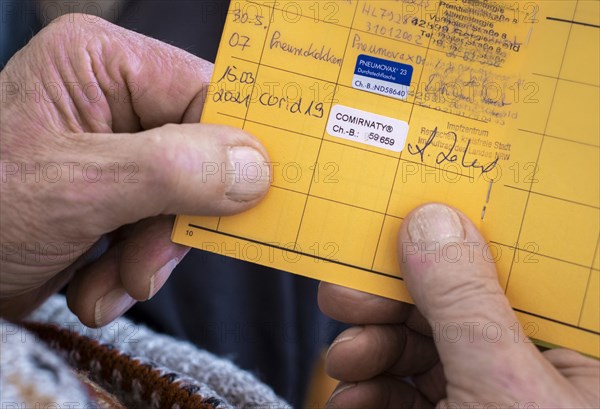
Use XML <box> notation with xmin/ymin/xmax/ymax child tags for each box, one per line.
<box><xmin>319</xmin><ymin>204</ymin><xmax>600</xmax><ymax>409</ymax></box>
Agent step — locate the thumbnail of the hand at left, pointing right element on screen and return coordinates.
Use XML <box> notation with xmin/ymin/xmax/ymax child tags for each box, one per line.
<box><xmin>227</xmin><ymin>146</ymin><xmax>271</xmax><ymax>202</ymax></box>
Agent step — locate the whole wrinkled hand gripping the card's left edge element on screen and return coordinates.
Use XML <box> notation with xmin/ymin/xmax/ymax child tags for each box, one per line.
<box><xmin>0</xmin><ymin>15</ymin><xmax>270</xmax><ymax>326</ymax></box>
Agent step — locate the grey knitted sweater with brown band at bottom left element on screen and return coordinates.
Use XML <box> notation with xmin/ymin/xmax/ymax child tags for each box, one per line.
<box><xmin>0</xmin><ymin>295</ymin><xmax>290</xmax><ymax>409</ymax></box>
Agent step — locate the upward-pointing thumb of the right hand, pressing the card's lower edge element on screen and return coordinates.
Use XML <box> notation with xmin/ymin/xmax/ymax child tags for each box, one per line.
<box><xmin>399</xmin><ymin>204</ymin><xmax>557</xmax><ymax>402</ymax></box>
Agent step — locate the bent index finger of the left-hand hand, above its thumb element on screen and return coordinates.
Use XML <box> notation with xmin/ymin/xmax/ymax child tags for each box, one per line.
<box><xmin>2</xmin><ymin>14</ymin><xmax>213</xmax><ymax>133</ymax></box>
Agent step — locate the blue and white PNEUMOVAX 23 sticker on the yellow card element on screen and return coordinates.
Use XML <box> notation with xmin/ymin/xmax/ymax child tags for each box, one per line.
<box><xmin>352</xmin><ymin>54</ymin><xmax>413</xmax><ymax>100</ymax></box>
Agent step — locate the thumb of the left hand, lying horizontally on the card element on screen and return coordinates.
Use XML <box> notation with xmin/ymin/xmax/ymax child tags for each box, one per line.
<box><xmin>69</xmin><ymin>124</ymin><xmax>270</xmax><ymax>233</ymax></box>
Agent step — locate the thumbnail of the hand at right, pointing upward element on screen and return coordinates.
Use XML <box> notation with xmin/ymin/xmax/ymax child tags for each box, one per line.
<box><xmin>408</xmin><ymin>203</ymin><xmax>465</xmax><ymax>243</ymax></box>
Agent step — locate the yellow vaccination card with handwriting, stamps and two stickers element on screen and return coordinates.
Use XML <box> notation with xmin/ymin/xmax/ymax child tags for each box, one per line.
<box><xmin>173</xmin><ymin>0</ymin><xmax>600</xmax><ymax>357</ymax></box>
